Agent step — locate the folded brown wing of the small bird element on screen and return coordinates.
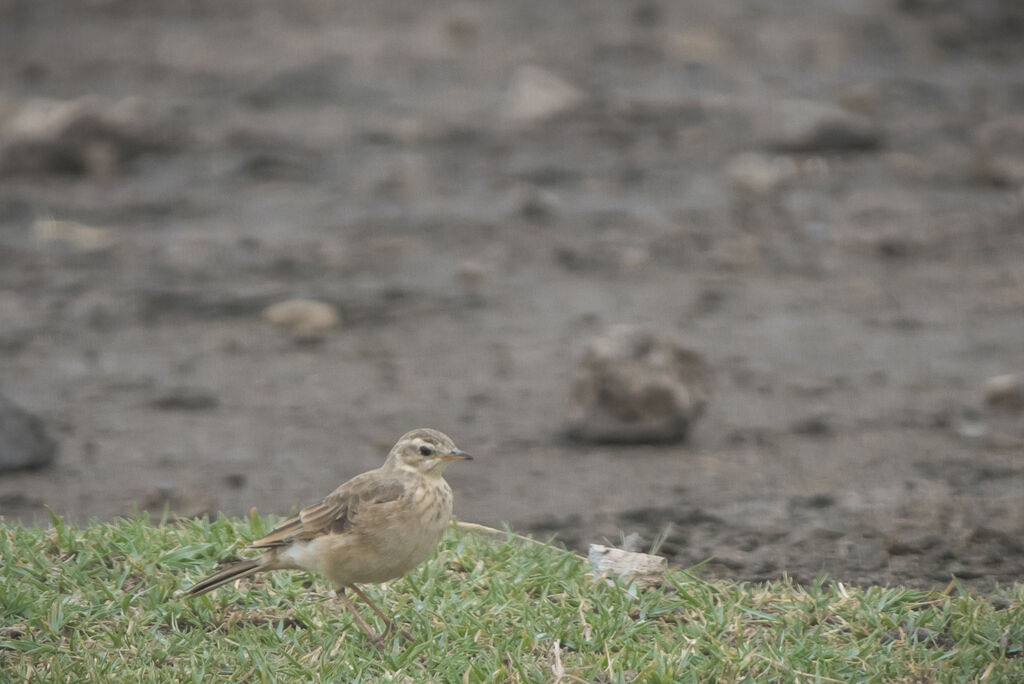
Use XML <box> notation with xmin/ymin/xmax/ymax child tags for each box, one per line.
<box><xmin>249</xmin><ymin>471</ymin><xmax>406</xmax><ymax>549</ymax></box>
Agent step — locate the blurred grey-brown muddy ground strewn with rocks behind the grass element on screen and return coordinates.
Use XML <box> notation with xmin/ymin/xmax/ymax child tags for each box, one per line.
<box><xmin>0</xmin><ymin>0</ymin><xmax>1024</xmax><ymax>588</ymax></box>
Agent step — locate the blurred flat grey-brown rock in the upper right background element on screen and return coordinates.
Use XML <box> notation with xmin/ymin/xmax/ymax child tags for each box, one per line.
<box><xmin>757</xmin><ymin>99</ymin><xmax>884</xmax><ymax>153</ymax></box>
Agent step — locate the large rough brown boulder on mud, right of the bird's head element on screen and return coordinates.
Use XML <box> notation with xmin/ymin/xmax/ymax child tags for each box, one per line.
<box><xmin>567</xmin><ymin>326</ymin><xmax>712</xmax><ymax>443</ymax></box>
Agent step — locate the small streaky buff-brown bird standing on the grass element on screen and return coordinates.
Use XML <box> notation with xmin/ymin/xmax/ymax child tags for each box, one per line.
<box><xmin>185</xmin><ymin>428</ymin><xmax>472</xmax><ymax>646</ymax></box>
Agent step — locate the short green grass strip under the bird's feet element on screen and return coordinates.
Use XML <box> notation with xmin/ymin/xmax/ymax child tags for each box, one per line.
<box><xmin>0</xmin><ymin>516</ymin><xmax>1024</xmax><ymax>683</ymax></box>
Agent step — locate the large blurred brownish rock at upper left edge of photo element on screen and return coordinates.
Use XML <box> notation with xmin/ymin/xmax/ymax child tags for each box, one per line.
<box><xmin>0</xmin><ymin>97</ymin><xmax>182</xmax><ymax>176</ymax></box>
